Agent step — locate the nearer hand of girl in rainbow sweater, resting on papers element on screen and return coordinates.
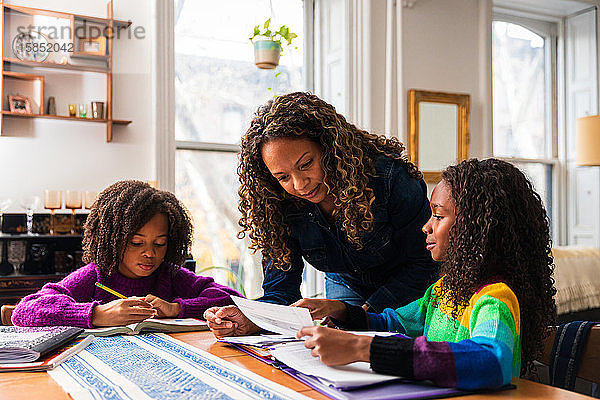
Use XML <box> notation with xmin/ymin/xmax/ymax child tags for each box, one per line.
<box><xmin>296</xmin><ymin>326</ymin><xmax>373</xmax><ymax>366</ymax></box>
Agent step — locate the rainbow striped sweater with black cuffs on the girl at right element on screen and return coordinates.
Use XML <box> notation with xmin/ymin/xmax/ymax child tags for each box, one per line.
<box><xmin>348</xmin><ymin>278</ymin><xmax>521</xmax><ymax>390</ymax></box>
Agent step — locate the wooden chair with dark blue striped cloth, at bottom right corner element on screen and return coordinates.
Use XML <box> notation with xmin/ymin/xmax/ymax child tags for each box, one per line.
<box><xmin>537</xmin><ymin>321</ymin><xmax>600</xmax><ymax>396</ymax></box>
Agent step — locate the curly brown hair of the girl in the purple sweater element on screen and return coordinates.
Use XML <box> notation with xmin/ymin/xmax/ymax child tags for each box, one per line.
<box><xmin>82</xmin><ymin>180</ymin><xmax>193</xmax><ymax>275</ymax></box>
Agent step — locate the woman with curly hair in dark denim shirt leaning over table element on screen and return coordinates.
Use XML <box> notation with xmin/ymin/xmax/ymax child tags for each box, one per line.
<box><xmin>205</xmin><ymin>92</ymin><xmax>437</xmax><ymax>335</ymax></box>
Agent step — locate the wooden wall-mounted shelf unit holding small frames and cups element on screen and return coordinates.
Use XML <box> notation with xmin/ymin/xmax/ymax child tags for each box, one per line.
<box><xmin>0</xmin><ymin>0</ymin><xmax>132</xmax><ymax>142</ymax></box>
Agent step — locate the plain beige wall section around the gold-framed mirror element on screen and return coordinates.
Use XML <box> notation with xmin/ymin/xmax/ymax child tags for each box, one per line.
<box><xmin>401</xmin><ymin>0</ymin><xmax>491</xmax><ymax>157</ymax></box>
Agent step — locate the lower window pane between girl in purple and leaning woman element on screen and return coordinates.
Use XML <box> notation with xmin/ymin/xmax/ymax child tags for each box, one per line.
<box><xmin>175</xmin><ymin>150</ymin><xmax>262</xmax><ymax>297</ymax></box>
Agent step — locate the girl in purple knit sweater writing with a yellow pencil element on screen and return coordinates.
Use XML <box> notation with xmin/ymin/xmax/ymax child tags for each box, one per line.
<box><xmin>12</xmin><ymin>181</ymin><xmax>239</xmax><ymax>328</ymax></box>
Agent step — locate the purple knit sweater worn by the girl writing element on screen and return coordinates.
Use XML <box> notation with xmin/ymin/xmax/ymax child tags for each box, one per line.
<box><xmin>12</xmin><ymin>263</ymin><xmax>240</xmax><ymax>328</ymax></box>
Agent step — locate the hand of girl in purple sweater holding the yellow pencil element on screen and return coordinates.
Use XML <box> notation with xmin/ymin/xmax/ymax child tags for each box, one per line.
<box><xmin>92</xmin><ymin>297</ymin><xmax>156</xmax><ymax>326</ymax></box>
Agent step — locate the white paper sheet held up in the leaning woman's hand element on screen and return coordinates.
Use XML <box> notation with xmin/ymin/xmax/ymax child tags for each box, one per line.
<box><xmin>231</xmin><ymin>296</ymin><xmax>313</xmax><ymax>336</ymax></box>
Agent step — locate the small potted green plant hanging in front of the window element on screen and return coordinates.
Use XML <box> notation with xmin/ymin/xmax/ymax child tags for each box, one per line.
<box><xmin>250</xmin><ymin>18</ymin><xmax>298</xmax><ymax>69</ymax></box>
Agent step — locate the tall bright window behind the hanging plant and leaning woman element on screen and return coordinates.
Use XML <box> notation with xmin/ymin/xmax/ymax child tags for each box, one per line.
<box><xmin>174</xmin><ymin>0</ymin><xmax>305</xmax><ymax>296</ymax></box>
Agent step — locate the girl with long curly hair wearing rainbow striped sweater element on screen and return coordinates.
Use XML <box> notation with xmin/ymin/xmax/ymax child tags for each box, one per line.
<box><xmin>298</xmin><ymin>159</ymin><xmax>556</xmax><ymax>390</ymax></box>
